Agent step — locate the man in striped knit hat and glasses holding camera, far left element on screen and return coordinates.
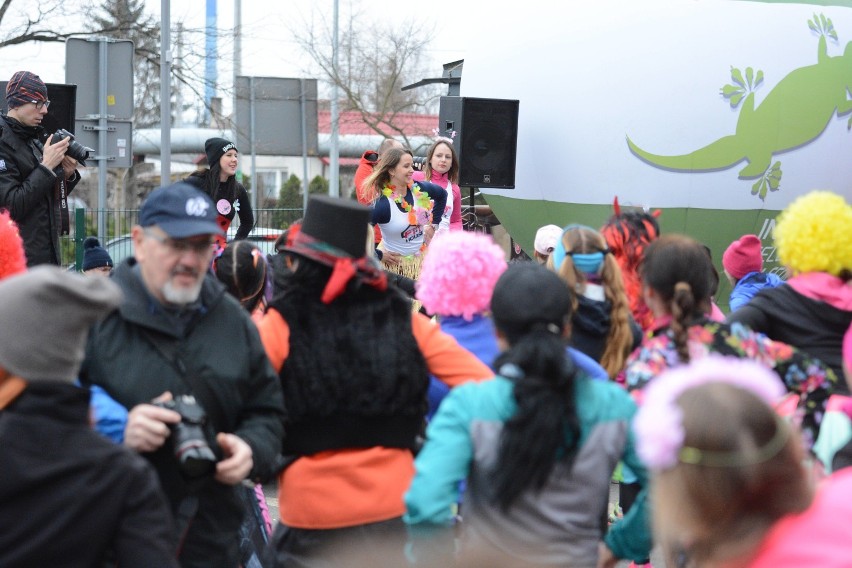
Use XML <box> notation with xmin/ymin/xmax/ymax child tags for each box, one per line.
<box><xmin>0</xmin><ymin>71</ymin><xmax>80</xmax><ymax>266</ymax></box>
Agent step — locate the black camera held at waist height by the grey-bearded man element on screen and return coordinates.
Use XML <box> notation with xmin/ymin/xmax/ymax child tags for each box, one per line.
<box><xmin>152</xmin><ymin>394</ymin><xmax>216</xmax><ymax>478</ymax></box>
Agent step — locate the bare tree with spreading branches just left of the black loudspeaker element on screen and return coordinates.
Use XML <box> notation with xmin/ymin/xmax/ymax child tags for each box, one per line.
<box><xmin>290</xmin><ymin>1</ymin><xmax>440</xmax><ymax>146</ymax></box>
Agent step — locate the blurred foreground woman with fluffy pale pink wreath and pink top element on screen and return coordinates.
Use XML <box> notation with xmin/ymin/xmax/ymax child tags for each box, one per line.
<box><xmin>634</xmin><ymin>355</ymin><xmax>852</xmax><ymax>568</ymax></box>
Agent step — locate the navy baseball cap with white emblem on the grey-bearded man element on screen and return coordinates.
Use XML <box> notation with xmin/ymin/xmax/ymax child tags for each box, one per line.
<box><xmin>139</xmin><ymin>182</ymin><xmax>224</xmax><ymax>239</ymax></box>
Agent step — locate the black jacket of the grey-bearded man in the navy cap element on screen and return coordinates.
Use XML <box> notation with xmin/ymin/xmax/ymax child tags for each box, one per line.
<box><xmin>80</xmin><ymin>258</ymin><xmax>284</xmax><ymax>568</ymax></box>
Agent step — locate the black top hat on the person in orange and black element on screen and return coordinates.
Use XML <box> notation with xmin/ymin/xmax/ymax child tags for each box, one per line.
<box><xmin>286</xmin><ymin>196</ymin><xmax>370</xmax><ymax>258</ymax></box>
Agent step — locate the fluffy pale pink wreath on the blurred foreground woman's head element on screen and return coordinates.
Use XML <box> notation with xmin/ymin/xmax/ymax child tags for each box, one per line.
<box><xmin>633</xmin><ymin>355</ymin><xmax>787</xmax><ymax>471</ymax></box>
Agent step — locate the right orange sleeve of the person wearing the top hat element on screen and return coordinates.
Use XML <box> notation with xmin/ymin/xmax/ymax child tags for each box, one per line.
<box><xmin>411</xmin><ymin>313</ymin><xmax>494</xmax><ymax>387</ymax></box>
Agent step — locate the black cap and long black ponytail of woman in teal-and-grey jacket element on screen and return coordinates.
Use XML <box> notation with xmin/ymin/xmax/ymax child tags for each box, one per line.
<box><xmin>490</xmin><ymin>264</ymin><xmax>580</xmax><ymax>510</ymax></box>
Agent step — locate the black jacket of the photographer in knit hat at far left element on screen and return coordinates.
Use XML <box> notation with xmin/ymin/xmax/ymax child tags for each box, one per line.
<box><xmin>0</xmin><ymin>116</ymin><xmax>80</xmax><ymax>266</ymax></box>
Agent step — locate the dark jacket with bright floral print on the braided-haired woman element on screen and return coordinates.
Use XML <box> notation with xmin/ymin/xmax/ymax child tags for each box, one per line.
<box><xmin>625</xmin><ymin>320</ymin><xmax>837</xmax><ymax>448</ymax></box>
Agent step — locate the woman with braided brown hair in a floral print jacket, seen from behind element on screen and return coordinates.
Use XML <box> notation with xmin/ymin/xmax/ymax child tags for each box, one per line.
<box><xmin>625</xmin><ymin>235</ymin><xmax>837</xmax><ymax>449</ymax></box>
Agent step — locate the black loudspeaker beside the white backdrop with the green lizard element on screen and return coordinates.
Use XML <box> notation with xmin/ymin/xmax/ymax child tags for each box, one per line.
<box><xmin>438</xmin><ymin>97</ymin><xmax>519</xmax><ymax>189</ymax></box>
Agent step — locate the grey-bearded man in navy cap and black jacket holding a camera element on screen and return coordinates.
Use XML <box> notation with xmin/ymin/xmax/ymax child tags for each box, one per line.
<box><xmin>80</xmin><ymin>183</ymin><xmax>284</xmax><ymax>568</ymax></box>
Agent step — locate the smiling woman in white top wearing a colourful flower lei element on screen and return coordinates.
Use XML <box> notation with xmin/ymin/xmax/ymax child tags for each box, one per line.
<box><xmin>364</xmin><ymin>148</ymin><xmax>447</xmax><ymax>286</ymax></box>
